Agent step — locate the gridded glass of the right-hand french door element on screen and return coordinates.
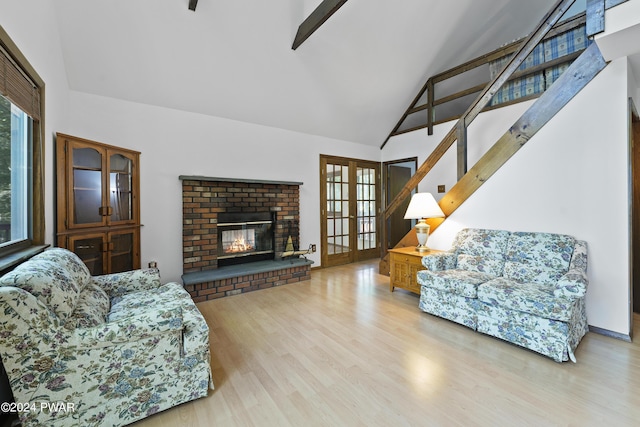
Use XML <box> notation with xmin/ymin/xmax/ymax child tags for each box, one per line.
<box><xmin>356</xmin><ymin>167</ymin><xmax>377</xmax><ymax>250</ymax></box>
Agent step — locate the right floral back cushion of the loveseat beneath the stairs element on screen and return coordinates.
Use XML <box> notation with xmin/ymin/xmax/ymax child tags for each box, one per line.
<box><xmin>502</xmin><ymin>232</ymin><xmax>575</xmax><ymax>285</ymax></box>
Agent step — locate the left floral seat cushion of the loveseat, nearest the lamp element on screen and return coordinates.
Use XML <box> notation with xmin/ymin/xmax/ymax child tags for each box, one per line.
<box><xmin>418</xmin><ymin>270</ymin><xmax>495</xmax><ymax>298</ymax></box>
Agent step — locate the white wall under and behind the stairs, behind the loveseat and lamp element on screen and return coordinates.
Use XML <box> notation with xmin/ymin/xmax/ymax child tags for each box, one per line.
<box><xmin>384</xmin><ymin>58</ymin><xmax>630</xmax><ymax>335</ymax></box>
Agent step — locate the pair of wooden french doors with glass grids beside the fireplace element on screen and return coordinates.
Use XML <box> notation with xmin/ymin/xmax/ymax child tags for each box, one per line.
<box><xmin>320</xmin><ymin>155</ymin><xmax>380</xmax><ymax>267</ymax></box>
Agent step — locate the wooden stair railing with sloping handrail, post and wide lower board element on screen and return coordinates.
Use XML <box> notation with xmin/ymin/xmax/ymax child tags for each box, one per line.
<box><xmin>379</xmin><ymin>0</ymin><xmax>606</xmax><ymax>274</ymax></box>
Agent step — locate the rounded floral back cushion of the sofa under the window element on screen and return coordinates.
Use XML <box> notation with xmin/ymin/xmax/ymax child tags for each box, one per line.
<box><xmin>0</xmin><ymin>258</ymin><xmax>80</xmax><ymax>322</ymax></box>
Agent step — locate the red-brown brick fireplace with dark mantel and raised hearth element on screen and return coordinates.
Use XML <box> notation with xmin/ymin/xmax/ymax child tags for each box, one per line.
<box><xmin>180</xmin><ymin>176</ymin><xmax>311</xmax><ymax>302</ymax></box>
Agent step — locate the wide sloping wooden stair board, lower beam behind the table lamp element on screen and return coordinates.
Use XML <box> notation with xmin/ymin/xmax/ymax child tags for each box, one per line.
<box><xmin>439</xmin><ymin>43</ymin><xmax>607</xmax><ymax>216</ymax></box>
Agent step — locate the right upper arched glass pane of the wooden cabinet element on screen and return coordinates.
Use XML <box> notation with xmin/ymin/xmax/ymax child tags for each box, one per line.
<box><xmin>109</xmin><ymin>154</ymin><xmax>133</xmax><ymax>221</ymax></box>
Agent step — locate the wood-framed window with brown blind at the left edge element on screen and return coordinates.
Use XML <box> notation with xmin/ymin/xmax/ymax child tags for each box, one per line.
<box><xmin>0</xmin><ymin>27</ymin><xmax>44</xmax><ymax>274</ymax></box>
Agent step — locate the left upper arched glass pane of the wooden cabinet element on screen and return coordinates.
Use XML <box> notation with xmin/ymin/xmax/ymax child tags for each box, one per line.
<box><xmin>73</xmin><ymin>148</ymin><xmax>102</xmax><ymax>224</ymax></box>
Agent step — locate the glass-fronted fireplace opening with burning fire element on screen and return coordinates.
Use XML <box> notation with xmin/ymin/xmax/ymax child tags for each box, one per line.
<box><xmin>218</xmin><ymin>212</ymin><xmax>275</xmax><ymax>266</ymax></box>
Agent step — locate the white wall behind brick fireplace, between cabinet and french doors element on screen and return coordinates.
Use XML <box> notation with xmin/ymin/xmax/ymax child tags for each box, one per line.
<box><xmin>62</xmin><ymin>91</ymin><xmax>380</xmax><ymax>281</ymax></box>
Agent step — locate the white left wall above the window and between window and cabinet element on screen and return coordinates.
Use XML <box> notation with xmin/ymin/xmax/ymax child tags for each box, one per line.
<box><xmin>0</xmin><ymin>0</ymin><xmax>69</xmax><ymax>251</ymax></box>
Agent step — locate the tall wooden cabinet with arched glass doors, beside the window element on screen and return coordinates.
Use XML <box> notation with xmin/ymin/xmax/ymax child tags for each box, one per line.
<box><xmin>56</xmin><ymin>133</ymin><xmax>140</xmax><ymax>275</ymax></box>
